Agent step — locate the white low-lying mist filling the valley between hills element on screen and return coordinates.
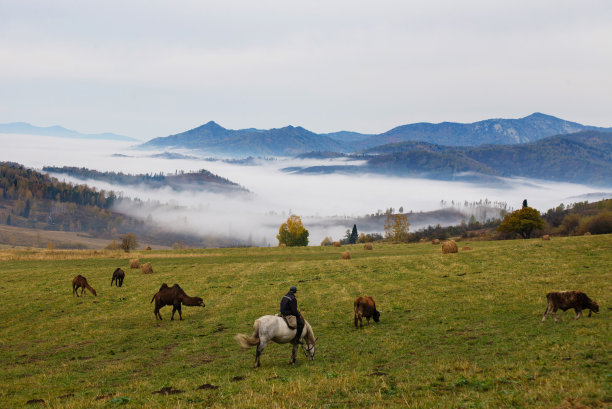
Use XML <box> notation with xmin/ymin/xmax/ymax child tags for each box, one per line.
<box><xmin>0</xmin><ymin>134</ymin><xmax>605</xmax><ymax>245</ymax></box>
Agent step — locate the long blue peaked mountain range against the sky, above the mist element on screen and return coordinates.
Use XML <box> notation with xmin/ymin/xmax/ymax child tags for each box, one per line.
<box><xmin>140</xmin><ymin>113</ymin><xmax>612</xmax><ymax>156</ymax></box>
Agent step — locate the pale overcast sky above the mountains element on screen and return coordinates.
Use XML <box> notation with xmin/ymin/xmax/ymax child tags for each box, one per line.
<box><xmin>0</xmin><ymin>0</ymin><xmax>612</xmax><ymax>139</ymax></box>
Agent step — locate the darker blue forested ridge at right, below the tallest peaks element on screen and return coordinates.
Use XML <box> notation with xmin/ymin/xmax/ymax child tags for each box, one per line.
<box><xmin>286</xmin><ymin>131</ymin><xmax>612</xmax><ymax>186</ymax></box>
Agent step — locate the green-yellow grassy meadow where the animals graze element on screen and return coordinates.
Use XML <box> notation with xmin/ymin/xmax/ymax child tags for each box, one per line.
<box><xmin>0</xmin><ymin>235</ymin><xmax>612</xmax><ymax>408</ymax></box>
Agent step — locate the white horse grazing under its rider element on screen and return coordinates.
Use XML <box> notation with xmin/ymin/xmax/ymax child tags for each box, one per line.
<box><xmin>235</xmin><ymin>315</ymin><xmax>317</xmax><ymax>368</ymax></box>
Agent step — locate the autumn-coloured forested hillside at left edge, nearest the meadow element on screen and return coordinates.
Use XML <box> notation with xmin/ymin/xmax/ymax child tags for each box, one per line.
<box><xmin>0</xmin><ymin>162</ymin><xmax>213</xmax><ymax>247</ymax></box>
